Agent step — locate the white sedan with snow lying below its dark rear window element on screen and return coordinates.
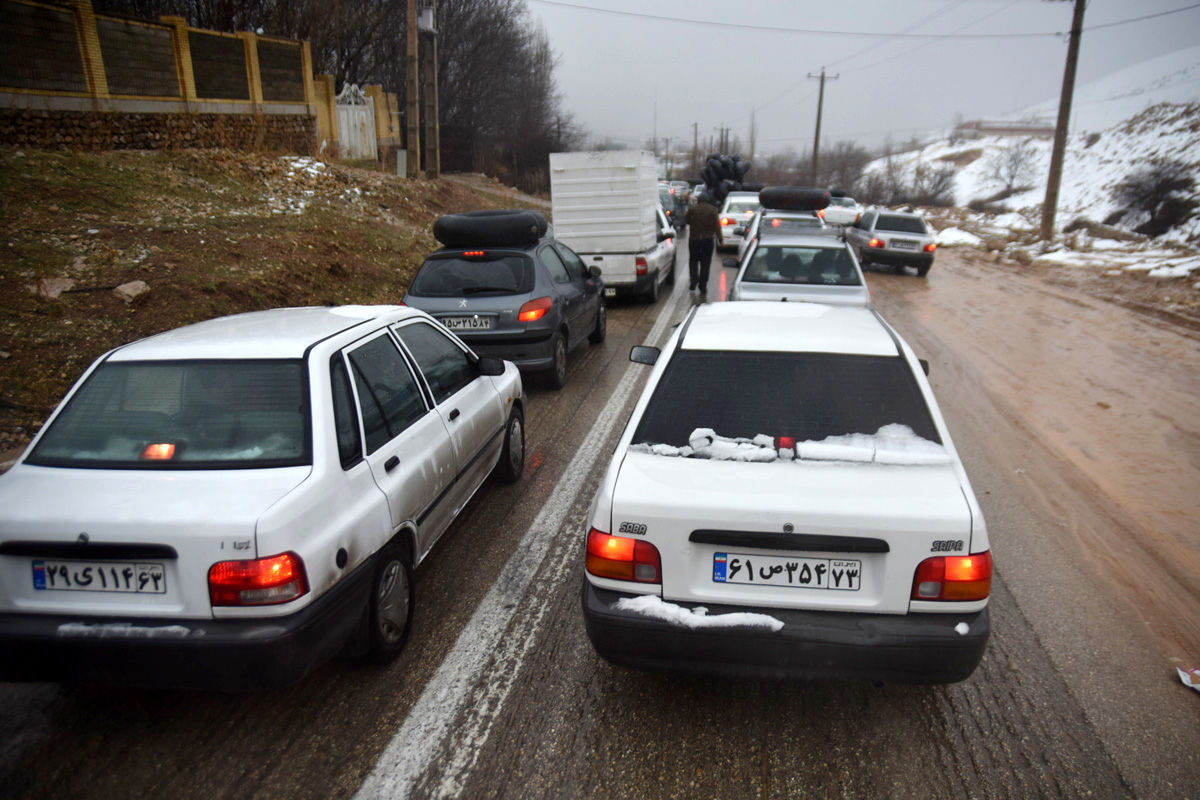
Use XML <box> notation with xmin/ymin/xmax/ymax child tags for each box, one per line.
<box><xmin>582</xmin><ymin>302</ymin><xmax>992</xmax><ymax>682</ymax></box>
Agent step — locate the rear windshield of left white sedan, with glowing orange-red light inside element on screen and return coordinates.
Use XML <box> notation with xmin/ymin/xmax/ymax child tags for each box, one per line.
<box><xmin>28</xmin><ymin>361</ymin><xmax>311</xmax><ymax>469</ymax></box>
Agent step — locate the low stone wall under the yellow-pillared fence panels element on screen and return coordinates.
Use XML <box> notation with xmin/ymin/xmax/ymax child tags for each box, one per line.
<box><xmin>0</xmin><ymin>109</ymin><xmax>316</xmax><ymax>154</ymax></box>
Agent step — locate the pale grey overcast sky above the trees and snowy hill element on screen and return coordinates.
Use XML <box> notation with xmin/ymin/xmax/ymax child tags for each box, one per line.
<box><xmin>528</xmin><ymin>0</ymin><xmax>1200</xmax><ymax>155</ymax></box>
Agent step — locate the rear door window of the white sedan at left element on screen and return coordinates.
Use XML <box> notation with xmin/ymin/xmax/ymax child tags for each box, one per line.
<box><xmin>349</xmin><ymin>333</ymin><xmax>427</xmax><ymax>455</ymax></box>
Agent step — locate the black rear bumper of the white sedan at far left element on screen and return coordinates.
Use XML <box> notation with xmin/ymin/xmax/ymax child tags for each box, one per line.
<box><xmin>0</xmin><ymin>558</ymin><xmax>374</xmax><ymax>692</ymax></box>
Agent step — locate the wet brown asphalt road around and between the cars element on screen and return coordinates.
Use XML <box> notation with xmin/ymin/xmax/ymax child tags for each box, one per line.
<box><xmin>0</xmin><ymin>244</ymin><xmax>1200</xmax><ymax>799</ymax></box>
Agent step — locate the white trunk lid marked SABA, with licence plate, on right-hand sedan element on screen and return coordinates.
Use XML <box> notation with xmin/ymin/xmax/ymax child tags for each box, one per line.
<box><xmin>612</xmin><ymin>450</ymin><xmax>971</xmax><ymax>614</ymax></box>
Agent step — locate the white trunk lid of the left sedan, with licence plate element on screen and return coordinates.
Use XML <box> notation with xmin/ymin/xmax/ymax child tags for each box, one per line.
<box><xmin>0</xmin><ymin>464</ymin><xmax>312</xmax><ymax>618</ymax></box>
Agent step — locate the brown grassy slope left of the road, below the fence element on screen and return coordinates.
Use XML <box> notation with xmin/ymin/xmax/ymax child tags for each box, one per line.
<box><xmin>0</xmin><ymin>148</ymin><xmax>535</xmax><ymax>459</ymax></box>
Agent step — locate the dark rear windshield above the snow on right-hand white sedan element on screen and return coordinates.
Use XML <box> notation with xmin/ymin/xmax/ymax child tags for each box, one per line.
<box><xmin>632</xmin><ymin>350</ymin><xmax>941</xmax><ymax>447</ymax></box>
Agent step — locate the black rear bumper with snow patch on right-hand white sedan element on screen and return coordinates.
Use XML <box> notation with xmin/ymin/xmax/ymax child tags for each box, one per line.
<box><xmin>582</xmin><ymin>579</ymin><xmax>990</xmax><ymax>684</ymax></box>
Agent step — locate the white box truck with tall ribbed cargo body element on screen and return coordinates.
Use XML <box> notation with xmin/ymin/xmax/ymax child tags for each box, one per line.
<box><xmin>550</xmin><ymin>150</ymin><xmax>676</xmax><ymax>302</ymax></box>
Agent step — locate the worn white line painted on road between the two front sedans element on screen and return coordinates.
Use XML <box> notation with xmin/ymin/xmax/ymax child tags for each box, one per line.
<box><xmin>354</xmin><ymin>284</ymin><xmax>685</xmax><ymax>800</ymax></box>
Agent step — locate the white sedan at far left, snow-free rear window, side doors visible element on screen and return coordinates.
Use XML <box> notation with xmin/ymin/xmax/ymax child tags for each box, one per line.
<box><xmin>0</xmin><ymin>306</ymin><xmax>524</xmax><ymax>691</ymax></box>
